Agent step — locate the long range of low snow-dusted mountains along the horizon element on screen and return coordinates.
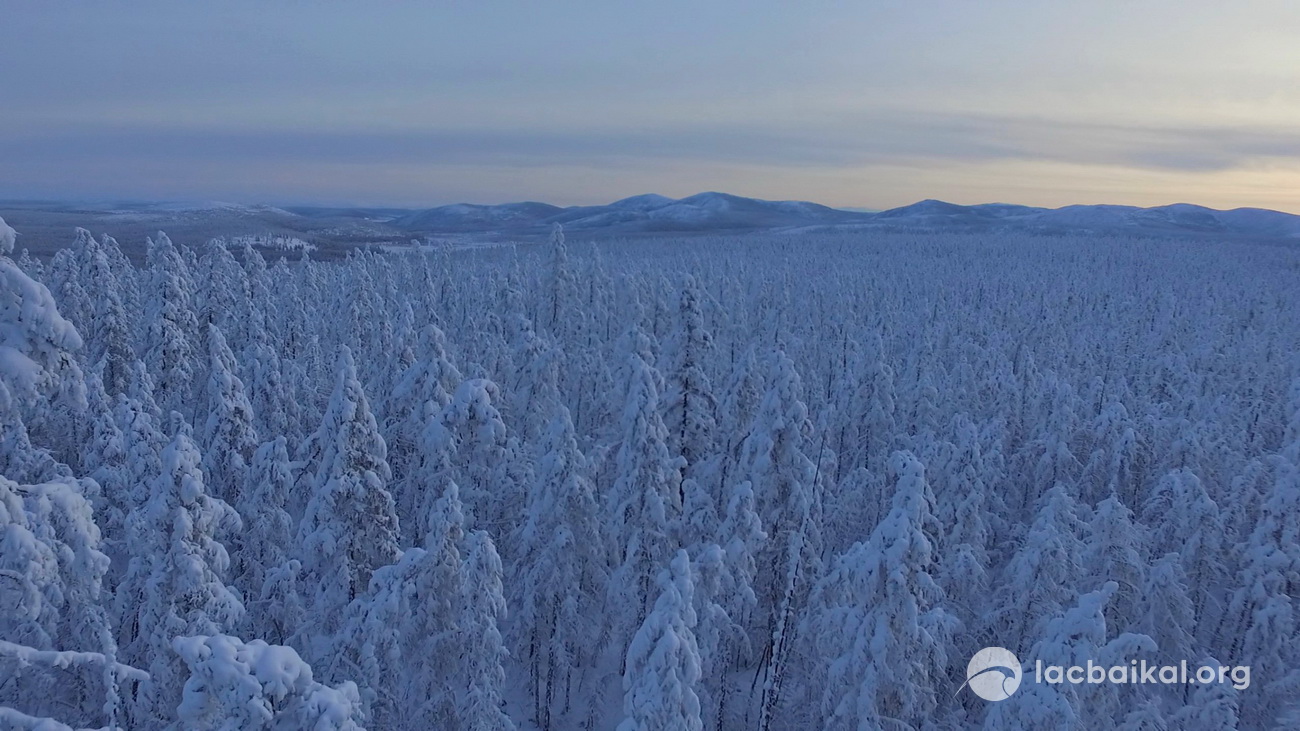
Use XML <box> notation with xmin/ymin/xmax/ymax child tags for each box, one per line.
<box><xmin>0</xmin><ymin>193</ymin><xmax>1300</xmax><ymax>258</ymax></box>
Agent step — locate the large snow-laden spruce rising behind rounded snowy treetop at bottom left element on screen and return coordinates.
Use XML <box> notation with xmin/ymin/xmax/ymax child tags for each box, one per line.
<box><xmin>125</xmin><ymin>414</ymin><xmax>244</xmax><ymax>726</ymax></box>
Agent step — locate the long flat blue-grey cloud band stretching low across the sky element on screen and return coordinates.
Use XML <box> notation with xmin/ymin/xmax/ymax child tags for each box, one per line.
<box><xmin>10</xmin><ymin>113</ymin><xmax>1300</xmax><ymax>172</ymax></box>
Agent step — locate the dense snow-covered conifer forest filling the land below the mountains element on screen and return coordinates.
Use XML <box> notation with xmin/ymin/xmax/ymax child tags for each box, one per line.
<box><xmin>0</xmin><ymin>217</ymin><xmax>1300</xmax><ymax>731</ymax></box>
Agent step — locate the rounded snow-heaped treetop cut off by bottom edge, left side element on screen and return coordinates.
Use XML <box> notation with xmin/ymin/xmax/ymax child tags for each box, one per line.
<box><xmin>172</xmin><ymin>635</ymin><xmax>363</xmax><ymax>731</ymax></box>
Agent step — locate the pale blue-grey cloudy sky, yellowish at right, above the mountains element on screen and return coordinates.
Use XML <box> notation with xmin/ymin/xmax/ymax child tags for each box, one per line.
<box><xmin>0</xmin><ymin>0</ymin><xmax>1300</xmax><ymax>212</ymax></box>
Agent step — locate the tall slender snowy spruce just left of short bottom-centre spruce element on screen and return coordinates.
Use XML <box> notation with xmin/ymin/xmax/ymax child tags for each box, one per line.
<box><xmin>511</xmin><ymin>406</ymin><xmax>608</xmax><ymax>728</ymax></box>
